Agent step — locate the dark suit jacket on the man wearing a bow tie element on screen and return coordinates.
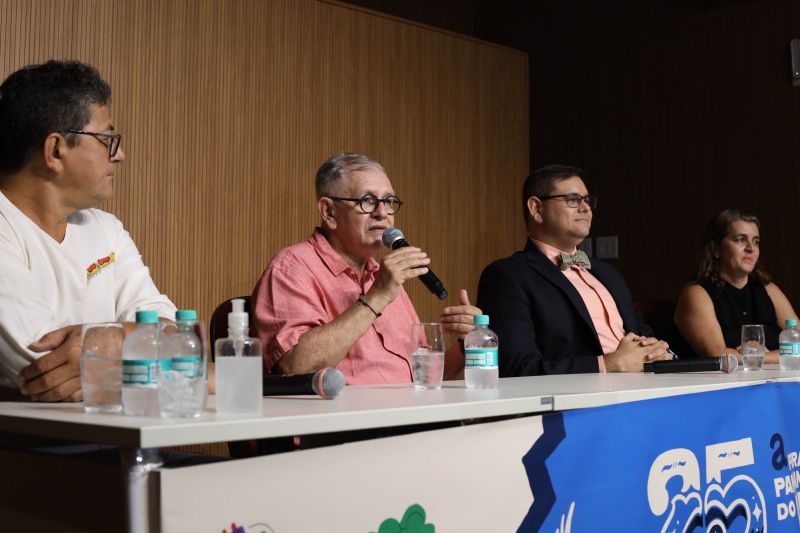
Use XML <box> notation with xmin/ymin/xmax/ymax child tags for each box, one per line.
<box><xmin>477</xmin><ymin>240</ymin><xmax>652</xmax><ymax>377</ymax></box>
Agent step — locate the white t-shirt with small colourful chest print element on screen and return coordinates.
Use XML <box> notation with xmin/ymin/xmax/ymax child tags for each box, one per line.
<box><xmin>0</xmin><ymin>193</ymin><xmax>175</xmax><ymax>386</ymax></box>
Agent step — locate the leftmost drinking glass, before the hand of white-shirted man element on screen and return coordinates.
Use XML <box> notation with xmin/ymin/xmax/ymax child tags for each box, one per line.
<box><xmin>81</xmin><ymin>322</ymin><xmax>125</xmax><ymax>413</ymax></box>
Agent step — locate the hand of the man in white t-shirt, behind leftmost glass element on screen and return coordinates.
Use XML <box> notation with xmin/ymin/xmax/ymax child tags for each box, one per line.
<box><xmin>19</xmin><ymin>324</ymin><xmax>83</xmax><ymax>402</ymax></box>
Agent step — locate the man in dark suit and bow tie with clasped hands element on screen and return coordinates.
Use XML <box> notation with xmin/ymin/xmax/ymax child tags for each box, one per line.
<box><xmin>477</xmin><ymin>165</ymin><xmax>672</xmax><ymax>377</ymax></box>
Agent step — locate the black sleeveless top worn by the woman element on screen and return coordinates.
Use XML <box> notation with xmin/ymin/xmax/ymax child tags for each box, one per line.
<box><xmin>700</xmin><ymin>277</ymin><xmax>781</xmax><ymax>350</ymax></box>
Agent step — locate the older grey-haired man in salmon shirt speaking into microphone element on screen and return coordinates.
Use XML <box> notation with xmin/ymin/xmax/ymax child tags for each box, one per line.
<box><xmin>253</xmin><ymin>153</ymin><xmax>480</xmax><ymax>385</ymax></box>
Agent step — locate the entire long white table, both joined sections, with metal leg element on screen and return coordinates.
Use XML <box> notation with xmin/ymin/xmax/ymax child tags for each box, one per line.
<box><xmin>0</xmin><ymin>368</ymin><xmax>788</xmax><ymax>532</ymax></box>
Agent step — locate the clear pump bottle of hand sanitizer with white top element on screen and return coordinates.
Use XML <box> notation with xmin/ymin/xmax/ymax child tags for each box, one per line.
<box><xmin>214</xmin><ymin>298</ymin><xmax>264</xmax><ymax>413</ymax></box>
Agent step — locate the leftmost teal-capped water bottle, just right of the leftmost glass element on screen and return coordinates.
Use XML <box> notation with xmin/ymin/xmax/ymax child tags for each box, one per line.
<box><xmin>122</xmin><ymin>309</ymin><xmax>161</xmax><ymax>416</ymax></box>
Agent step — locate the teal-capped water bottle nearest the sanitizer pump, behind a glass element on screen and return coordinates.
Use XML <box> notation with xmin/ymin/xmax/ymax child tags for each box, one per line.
<box><xmin>158</xmin><ymin>309</ymin><xmax>208</xmax><ymax>417</ymax></box>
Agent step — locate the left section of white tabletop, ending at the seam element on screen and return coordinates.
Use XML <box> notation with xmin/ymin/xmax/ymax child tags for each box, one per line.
<box><xmin>0</xmin><ymin>378</ymin><xmax>552</xmax><ymax>448</ymax></box>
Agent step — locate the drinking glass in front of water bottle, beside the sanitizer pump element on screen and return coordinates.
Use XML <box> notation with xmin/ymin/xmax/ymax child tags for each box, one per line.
<box><xmin>156</xmin><ymin>320</ymin><xmax>209</xmax><ymax>418</ymax></box>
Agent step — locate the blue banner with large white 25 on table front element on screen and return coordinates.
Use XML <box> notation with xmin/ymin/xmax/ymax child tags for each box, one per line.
<box><xmin>519</xmin><ymin>383</ymin><xmax>800</xmax><ymax>533</ymax></box>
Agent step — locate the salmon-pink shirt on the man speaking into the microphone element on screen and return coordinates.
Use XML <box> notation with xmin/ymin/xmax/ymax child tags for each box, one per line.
<box><xmin>252</xmin><ymin>228</ymin><xmax>419</xmax><ymax>385</ymax></box>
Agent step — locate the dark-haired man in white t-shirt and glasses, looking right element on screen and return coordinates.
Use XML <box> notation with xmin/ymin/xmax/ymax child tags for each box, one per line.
<box><xmin>0</xmin><ymin>61</ymin><xmax>175</xmax><ymax>401</ymax></box>
